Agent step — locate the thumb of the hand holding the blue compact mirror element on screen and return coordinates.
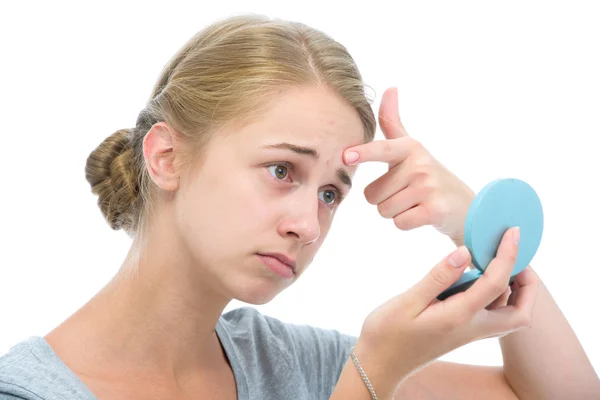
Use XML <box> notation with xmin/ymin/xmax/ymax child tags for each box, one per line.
<box><xmin>404</xmin><ymin>246</ymin><xmax>471</xmax><ymax>315</ymax></box>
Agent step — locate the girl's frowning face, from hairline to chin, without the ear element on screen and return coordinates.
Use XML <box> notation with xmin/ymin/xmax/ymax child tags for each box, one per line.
<box><xmin>174</xmin><ymin>87</ymin><xmax>364</xmax><ymax>304</ymax></box>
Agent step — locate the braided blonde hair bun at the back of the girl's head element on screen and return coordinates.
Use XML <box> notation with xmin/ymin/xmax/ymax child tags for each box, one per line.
<box><xmin>85</xmin><ymin>129</ymin><xmax>138</xmax><ymax>232</ymax></box>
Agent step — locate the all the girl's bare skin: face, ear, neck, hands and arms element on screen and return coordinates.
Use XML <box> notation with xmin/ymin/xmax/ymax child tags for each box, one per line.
<box><xmin>46</xmin><ymin>87</ymin><xmax>598</xmax><ymax>400</ymax></box>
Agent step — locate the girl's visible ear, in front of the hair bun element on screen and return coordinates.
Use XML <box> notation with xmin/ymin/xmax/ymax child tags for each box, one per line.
<box><xmin>144</xmin><ymin>122</ymin><xmax>179</xmax><ymax>191</ymax></box>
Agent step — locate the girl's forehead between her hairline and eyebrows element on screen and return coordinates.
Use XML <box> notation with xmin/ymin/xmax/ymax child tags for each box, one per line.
<box><xmin>229</xmin><ymin>87</ymin><xmax>364</xmax><ymax>152</ymax></box>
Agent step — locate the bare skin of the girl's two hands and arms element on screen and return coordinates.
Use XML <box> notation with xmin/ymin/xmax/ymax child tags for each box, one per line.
<box><xmin>332</xmin><ymin>88</ymin><xmax>600</xmax><ymax>400</ymax></box>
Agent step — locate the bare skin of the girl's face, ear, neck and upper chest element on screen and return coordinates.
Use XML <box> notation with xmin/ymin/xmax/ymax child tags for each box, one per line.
<box><xmin>46</xmin><ymin>87</ymin><xmax>364</xmax><ymax>398</ymax></box>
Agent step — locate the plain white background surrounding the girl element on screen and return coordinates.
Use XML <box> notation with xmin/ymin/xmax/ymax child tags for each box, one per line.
<box><xmin>0</xmin><ymin>1</ymin><xmax>600</xmax><ymax>371</ymax></box>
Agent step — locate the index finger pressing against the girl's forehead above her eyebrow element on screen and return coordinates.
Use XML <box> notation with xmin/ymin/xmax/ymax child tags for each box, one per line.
<box><xmin>344</xmin><ymin>137</ymin><xmax>413</xmax><ymax>167</ymax></box>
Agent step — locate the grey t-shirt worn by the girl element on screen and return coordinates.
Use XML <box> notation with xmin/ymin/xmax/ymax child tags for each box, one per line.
<box><xmin>0</xmin><ymin>307</ymin><xmax>357</xmax><ymax>400</ymax></box>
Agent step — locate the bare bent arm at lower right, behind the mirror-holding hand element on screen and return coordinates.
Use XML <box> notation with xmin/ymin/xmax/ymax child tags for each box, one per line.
<box><xmin>394</xmin><ymin>267</ymin><xmax>600</xmax><ymax>400</ymax></box>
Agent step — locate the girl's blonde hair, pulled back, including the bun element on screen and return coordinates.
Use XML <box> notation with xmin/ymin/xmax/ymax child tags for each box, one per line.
<box><xmin>85</xmin><ymin>14</ymin><xmax>376</xmax><ymax>236</ymax></box>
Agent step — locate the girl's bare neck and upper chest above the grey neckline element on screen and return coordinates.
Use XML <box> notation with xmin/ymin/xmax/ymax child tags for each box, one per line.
<box><xmin>46</xmin><ymin>216</ymin><xmax>230</xmax><ymax>379</ymax></box>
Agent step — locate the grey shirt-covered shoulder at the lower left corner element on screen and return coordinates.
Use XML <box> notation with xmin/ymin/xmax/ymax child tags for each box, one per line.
<box><xmin>0</xmin><ymin>336</ymin><xmax>95</xmax><ymax>400</ymax></box>
